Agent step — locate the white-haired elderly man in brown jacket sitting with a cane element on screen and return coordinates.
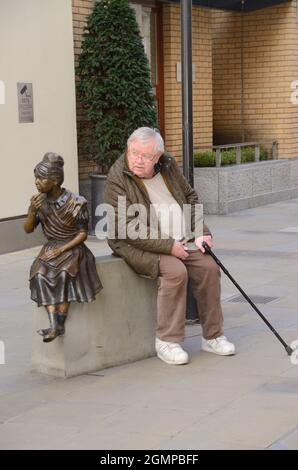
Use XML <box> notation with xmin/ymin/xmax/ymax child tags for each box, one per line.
<box><xmin>105</xmin><ymin>127</ymin><xmax>235</xmax><ymax>364</ymax></box>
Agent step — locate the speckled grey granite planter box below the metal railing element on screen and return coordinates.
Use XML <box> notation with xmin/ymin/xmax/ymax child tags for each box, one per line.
<box><xmin>194</xmin><ymin>159</ymin><xmax>298</xmax><ymax>214</ymax></box>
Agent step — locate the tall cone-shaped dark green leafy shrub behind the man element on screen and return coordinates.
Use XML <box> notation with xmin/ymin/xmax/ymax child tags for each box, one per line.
<box><xmin>77</xmin><ymin>0</ymin><xmax>157</xmax><ymax>172</ymax></box>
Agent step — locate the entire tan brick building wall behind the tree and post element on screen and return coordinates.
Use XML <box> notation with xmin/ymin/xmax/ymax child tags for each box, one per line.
<box><xmin>72</xmin><ymin>0</ymin><xmax>298</xmax><ymax>180</ymax></box>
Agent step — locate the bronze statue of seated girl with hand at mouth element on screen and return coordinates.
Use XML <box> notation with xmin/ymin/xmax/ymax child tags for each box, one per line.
<box><xmin>24</xmin><ymin>152</ymin><xmax>102</xmax><ymax>342</ymax></box>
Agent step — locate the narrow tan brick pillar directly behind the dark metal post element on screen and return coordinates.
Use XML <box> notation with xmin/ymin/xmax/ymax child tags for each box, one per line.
<box><xmin>163</xmin><ymin>5</ymin><xmax>212</xmax><ymax>162</ymax></box>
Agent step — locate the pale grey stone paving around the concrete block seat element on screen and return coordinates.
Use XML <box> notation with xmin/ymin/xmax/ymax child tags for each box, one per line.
<box><xmin>0</xmin><ymin>199</ymin><xmax>298</xmax><ymax>450</ymax></box>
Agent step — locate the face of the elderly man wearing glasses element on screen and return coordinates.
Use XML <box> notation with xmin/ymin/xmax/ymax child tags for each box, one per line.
<box><xmin>127</xmin><ymin>139</ymin><xmax>161</xmax><ymax>178</ymax></box>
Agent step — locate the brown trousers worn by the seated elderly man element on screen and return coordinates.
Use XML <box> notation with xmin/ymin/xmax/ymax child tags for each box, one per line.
<box><xmin>156</xmin><ymin>251</ymin><xmax>223</xmax><ymax>343</ymax></box>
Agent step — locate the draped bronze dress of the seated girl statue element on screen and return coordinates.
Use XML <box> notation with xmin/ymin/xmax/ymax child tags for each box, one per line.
<box><xmin>30</xmin><ymin>189</ymin><xmax>102</xmax><ymax>306</ymax></box>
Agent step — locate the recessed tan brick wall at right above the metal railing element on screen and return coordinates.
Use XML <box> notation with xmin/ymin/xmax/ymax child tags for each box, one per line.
<box><xmin>213</xmin><ymin>1</ymin><xmax>298</xmax><ymax>158</ymax></box>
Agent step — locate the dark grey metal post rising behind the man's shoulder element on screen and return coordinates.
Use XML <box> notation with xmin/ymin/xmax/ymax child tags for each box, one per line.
<box><xmin>180</xmin><ymin>0</ymin><xmax>193</xmax><ymax>186</ymax></box>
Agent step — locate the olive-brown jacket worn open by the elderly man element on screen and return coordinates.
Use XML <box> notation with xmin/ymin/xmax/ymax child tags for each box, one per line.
<box><xmin>105</xmin><ymin>154</ymin><xmax>211</xmax><ymax>279</ymax></box>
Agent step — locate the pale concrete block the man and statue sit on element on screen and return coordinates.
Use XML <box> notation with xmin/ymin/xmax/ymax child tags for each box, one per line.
<box><xmin>32</xmin><ymin>256</ymin><xmax>157</xmax><ymax>377</ymax></box>
